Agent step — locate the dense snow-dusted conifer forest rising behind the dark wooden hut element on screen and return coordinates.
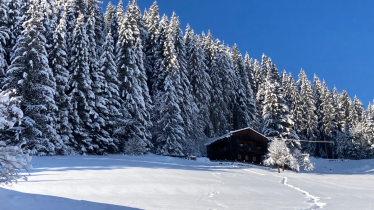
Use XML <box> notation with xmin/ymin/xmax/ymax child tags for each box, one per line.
<box><xmin>0</xmin><ymin>0</ymin><xmax>374</xmax><ymax>158</ymax></box>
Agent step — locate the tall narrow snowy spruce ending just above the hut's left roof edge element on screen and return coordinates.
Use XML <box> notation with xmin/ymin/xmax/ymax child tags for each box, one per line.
<box><xmin>185</xmin><ymin>33</ymin><xmax>213</xmax><ymax>137</ymax></box>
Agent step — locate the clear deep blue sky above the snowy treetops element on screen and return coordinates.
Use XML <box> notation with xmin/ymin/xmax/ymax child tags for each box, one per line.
<box><xmin>103</xmin><ymin>0</ymin><xmax>374</xmax><ymax>107</ymax></box>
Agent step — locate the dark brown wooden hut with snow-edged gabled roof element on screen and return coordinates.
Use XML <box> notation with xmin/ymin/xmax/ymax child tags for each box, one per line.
<box><xmin>205</xmin><ymin>128</ymin><xmax>268</xmax><ymax>163</ymax></box>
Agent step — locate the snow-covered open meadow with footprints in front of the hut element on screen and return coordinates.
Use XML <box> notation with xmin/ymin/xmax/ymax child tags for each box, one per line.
<box><xmin>0</xmin><ymin>155</ymin><xmax>374</xmax><ymax>210</ymax></box>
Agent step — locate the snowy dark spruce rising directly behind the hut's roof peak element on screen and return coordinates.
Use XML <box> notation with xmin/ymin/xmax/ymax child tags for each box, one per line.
<box><xmin>231</xmin><ymin>44</ymin><xmax>257</xmax><ymax>130</ymax></box>
